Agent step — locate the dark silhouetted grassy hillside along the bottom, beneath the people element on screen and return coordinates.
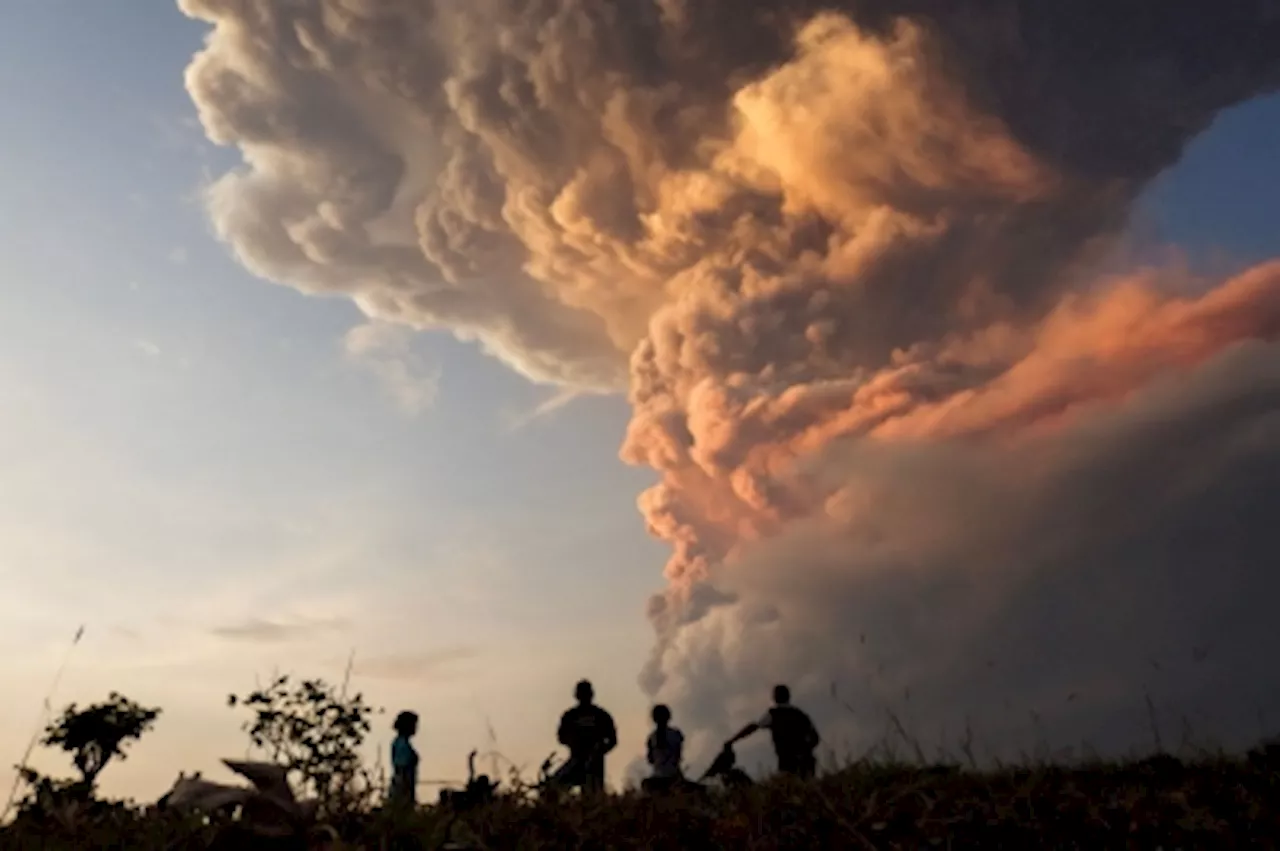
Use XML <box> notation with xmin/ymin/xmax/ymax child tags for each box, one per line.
<box><xmin>0</xmin><ymin>745</ymin><xmax>1280</xmax><ymax>851</ymax></box>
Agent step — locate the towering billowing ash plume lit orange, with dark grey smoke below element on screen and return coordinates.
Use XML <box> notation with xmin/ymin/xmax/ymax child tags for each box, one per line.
<box><xmin>180</xmin><ymin>0</ymin><xmax>1280</xmax><ymax>757</ymax></box>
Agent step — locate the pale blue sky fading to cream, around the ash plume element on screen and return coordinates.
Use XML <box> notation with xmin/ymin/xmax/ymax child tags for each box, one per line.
<box><xmin>0</xmin><ymin>0</ymin><xmax>1280</xmax><ymax>796</ymax></box>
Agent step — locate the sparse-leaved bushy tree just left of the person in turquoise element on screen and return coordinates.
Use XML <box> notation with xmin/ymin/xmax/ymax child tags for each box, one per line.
<box><xmin>228</xmin><ymin>674</ymin><xmax>383</xmax><ymax>813</ymax></box>
